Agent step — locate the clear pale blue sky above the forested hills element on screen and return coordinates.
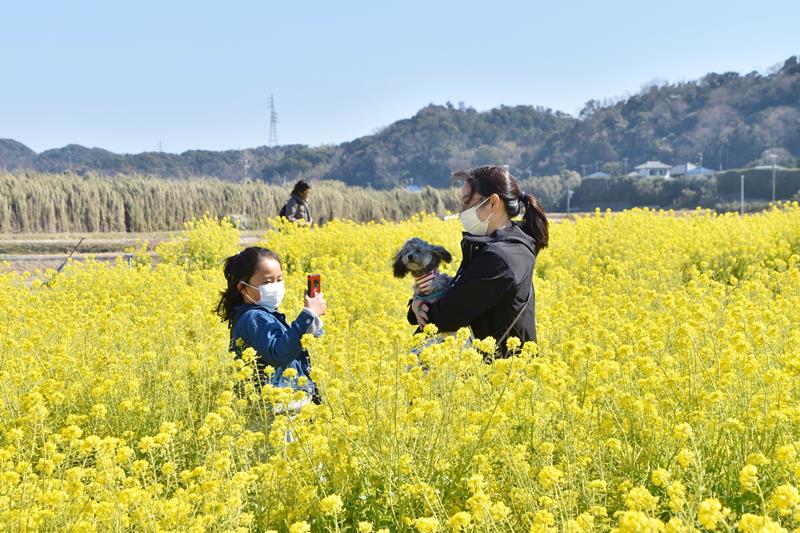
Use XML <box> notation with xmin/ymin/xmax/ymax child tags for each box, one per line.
<box><xmin>0</xmin><ymin>0</ymin><xmax>800</xmax><ymax>152</ymax></box>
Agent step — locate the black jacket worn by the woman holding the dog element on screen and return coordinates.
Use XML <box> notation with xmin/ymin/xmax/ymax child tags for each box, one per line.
<box><xmin>408</xmin><ymin>223</ymin><xmax>536</xmax><ymax>355</ymax></box>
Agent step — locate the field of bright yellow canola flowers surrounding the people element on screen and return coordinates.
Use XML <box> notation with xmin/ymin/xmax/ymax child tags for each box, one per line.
<box><xmin>0</xmin><ymin>203</ymin><xmax>800</xmax><ymax>533</ymax></box>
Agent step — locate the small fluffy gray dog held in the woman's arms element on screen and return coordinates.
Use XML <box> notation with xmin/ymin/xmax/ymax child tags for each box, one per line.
<box><xmin>394</xmin><ymin>237</ymin><xmax>453</xmax><ymax>303</ymax></box>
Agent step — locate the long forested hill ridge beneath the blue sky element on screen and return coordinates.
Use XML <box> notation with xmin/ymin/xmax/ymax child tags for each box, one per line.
<box><xmin>0</xmin><ymin>57</ymin><xmax>800</xmax><ymax>187</ymax></box>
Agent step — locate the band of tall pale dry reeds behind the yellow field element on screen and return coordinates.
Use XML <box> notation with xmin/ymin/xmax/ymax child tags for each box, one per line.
<box><xmin>0</xmin><ymin>172</ymin><xmax>458</xmax><ymax>233</ymax></box>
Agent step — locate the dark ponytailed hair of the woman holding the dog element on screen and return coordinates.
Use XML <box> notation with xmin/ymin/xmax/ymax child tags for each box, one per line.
<box><xmin>452</xmin><ymin>166</ymin><xmax>550</xmax><ymax>253</ymax></box>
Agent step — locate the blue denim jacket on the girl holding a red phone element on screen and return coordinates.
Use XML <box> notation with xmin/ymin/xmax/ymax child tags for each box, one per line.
<box><xmin>230</xmin><ymin>303</ymin><xmax>317</xmax><ymax>397</ymax></box>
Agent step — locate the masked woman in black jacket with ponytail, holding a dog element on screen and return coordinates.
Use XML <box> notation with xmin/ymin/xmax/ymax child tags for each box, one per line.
<box><xmin>408</xmin><ymin>166</ymin><xmax>549</xmax><ymax>356</ymax></box>
